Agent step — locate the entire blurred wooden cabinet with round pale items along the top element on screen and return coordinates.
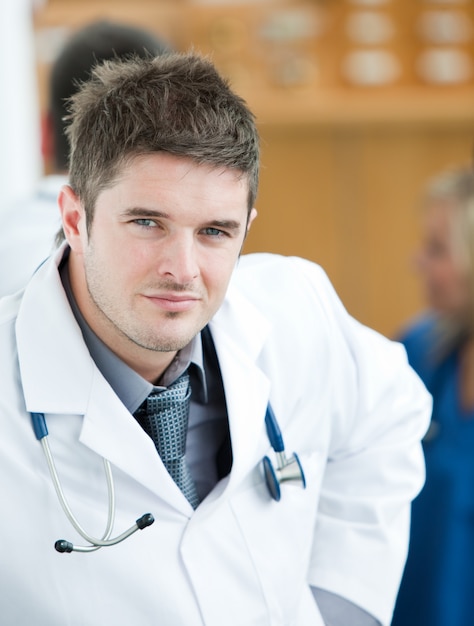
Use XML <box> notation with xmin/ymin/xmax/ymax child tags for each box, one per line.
<box><xmin>35</xmin><ymin>0</ymin><xmax>474</xmax><ymax>335</ymax></box>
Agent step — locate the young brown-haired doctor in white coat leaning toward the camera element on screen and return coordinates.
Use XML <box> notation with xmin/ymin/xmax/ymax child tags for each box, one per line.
<box><xmin>0</xmin><ymin>54</ymin><xmax>431</xmax><ymax>626</ymax></box>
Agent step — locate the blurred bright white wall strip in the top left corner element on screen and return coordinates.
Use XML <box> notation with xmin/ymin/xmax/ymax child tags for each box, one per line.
<box><xmin>0</xmin><ymin>0</ymin><xmax>42</xmax><ymax>213</ymax></box>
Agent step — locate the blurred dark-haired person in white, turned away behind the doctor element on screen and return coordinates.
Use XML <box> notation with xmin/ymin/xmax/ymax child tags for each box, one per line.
<box><xmin>0</xmin><ymin>20</ymin><xmax>170</xmax><ymax>297</ymax></box>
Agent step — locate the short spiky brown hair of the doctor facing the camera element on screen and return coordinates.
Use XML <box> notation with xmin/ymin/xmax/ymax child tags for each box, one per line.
<box><xmin>67</xmin><ymin>53</ymin><xmax>259</xmax><ymax>234</ymax></box>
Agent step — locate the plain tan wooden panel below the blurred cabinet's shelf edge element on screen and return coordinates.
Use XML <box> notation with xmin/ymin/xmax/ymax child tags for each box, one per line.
<box><xmin>254</xmin><ymin>120</ymin><xmax>474</xmax><ymax>335</ymax></box>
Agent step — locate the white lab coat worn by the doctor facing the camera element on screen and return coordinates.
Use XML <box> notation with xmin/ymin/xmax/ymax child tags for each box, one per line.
<box><xmin>0</xmin><ymin>246</ymin><xmax>431</xmax><ymax>626</ymax></box>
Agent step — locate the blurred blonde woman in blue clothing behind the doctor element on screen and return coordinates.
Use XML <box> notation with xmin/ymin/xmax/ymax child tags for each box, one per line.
<box><xmin>393</xmin><ymin>168</ymin><xmax>474</xmax><ymax>626</ymax></box>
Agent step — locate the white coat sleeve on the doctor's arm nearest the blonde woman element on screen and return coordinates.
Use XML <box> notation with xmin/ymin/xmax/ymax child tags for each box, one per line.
<box><xmin>296</xmin><ymin>262</ymin><xmax>431</xmax><ymax>626</ymax></box>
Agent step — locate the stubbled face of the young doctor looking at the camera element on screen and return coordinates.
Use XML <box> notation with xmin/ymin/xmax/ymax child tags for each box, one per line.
<box><xmin>60</xmin><ymin>153</ymin><xmax>255</xmax><ymax>378</ymax></box>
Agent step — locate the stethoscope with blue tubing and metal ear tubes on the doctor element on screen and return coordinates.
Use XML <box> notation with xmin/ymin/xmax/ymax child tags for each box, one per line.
<box><xmin>31</xmin><ymin>405</ymin><xmax>306</xmax><ymax>553</ymax></box>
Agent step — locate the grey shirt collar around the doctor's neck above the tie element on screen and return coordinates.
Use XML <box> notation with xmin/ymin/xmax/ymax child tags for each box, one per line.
<box><xmin>60</xmin><ymin>251</ymin><xmax>207</xmax><ymax>413</ymax></box>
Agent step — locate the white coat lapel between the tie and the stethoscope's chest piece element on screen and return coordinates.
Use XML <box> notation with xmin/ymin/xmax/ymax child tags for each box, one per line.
<box><xmin>210</xmin><ymin>288</ymin><xmax>270</xmax><ymax>490</ymax></box>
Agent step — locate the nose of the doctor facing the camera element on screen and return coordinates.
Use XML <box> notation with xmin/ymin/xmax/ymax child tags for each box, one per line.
<box><xmin>157</xmin><ymin>233</ymin><xmax>199</xmax><ymax>285</ymax></box>
